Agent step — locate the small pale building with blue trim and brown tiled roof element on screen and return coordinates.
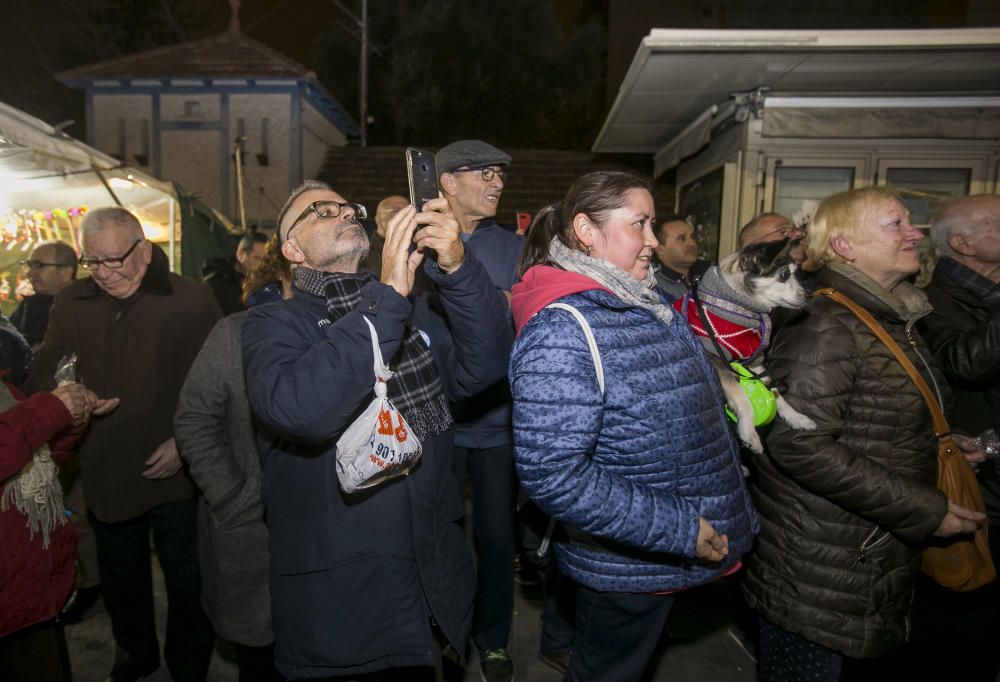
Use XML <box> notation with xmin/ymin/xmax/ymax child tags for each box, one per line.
<box><xmin>59</xmin><ymin>24</ymin><xmax>358</xmax><ymax>225</ymax></box>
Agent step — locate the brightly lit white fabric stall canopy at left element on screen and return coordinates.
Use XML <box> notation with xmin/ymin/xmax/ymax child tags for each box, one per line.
<box><xmin>0</xmin><ymin>102</ymin><xmax>175</xmax><ymax>243</ymax></box>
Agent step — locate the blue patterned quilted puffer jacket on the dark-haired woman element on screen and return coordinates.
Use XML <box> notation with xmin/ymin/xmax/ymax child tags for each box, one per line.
<box><xmin>510</xmin><ymin>290</ymin><xmax>757</xmax><ymax>592</ymax></box>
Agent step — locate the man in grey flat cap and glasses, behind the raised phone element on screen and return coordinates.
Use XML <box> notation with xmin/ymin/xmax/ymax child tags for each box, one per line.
<box><xmin>435</xmin><ymin>140</ymin><xmax>524</xmax><ymax>682</ymax></box>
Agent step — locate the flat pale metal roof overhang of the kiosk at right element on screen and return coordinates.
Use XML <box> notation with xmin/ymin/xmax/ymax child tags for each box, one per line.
<box><xmin>592</xmin><ymin>28</ymin><xmax>1000</xmax><ymax>170</ymax></box>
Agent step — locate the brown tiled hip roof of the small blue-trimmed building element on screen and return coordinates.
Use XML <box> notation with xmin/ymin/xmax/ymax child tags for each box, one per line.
<box><xmin>58</xmin><ymin>31</ymin><xmax>315</xmax><ymax>81</ymax></box>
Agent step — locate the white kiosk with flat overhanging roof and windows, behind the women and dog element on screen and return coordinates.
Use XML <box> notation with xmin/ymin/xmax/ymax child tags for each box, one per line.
<box><xmin>592</xmin><ymin>28</ymin><xmax>1000</xmax><ymax>260</ymax></box>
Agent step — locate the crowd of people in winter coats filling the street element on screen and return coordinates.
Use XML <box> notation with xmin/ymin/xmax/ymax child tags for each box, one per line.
<box><xmin>0</xmin><ymin>140</ymin><xmax>1000</xmax><ymax>682</ymax></box>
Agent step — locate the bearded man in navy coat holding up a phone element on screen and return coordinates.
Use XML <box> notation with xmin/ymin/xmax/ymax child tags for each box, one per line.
<box><xmin>243</xmin><ymin>181</ymin><xmax>513</xmax><ymax>679</ymax></box>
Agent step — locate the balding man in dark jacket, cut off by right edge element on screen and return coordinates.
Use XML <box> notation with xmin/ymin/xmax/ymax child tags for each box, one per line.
<box><xmin>912</xmin><ymin>194</ymin><xmax>1000</xmax><ymax>682</ymax></box>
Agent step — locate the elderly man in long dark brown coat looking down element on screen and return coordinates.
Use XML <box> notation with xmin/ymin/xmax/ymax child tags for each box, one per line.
<box><xmin>27</xmin><ymin>207</ymin><xmax>222</xmax><ymax>682</ymax></box>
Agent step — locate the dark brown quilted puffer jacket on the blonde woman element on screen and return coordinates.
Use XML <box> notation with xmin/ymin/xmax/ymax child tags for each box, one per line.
<box><xmin>744</xmin><ymin>262</ymin><xmax>947</xmax><ymax>658</ymax></box>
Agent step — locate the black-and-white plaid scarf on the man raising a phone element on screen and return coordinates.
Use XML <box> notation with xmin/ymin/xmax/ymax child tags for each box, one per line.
<box><xmin>295</xmin><ymin>267</ymin><xmax>453</xmax><ymax>441</ymax></box>
